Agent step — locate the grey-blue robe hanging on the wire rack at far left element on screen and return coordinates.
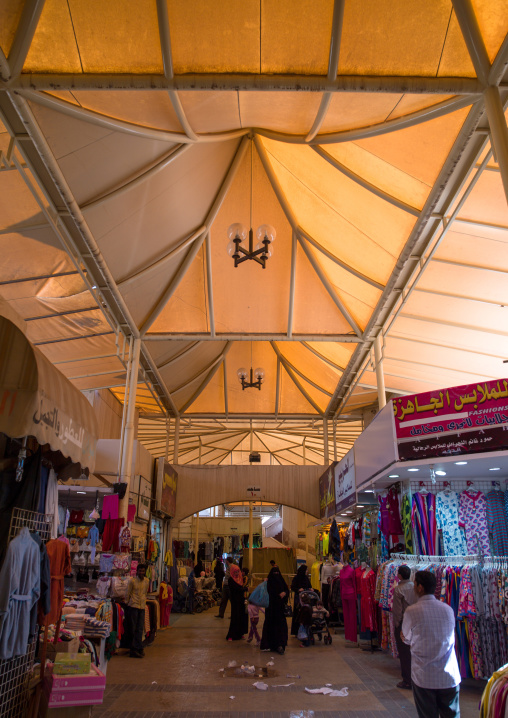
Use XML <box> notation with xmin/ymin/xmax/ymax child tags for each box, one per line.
<box><xmin>0</xmin><ymin>526</ymin><xmax>41</xmax><ymax>659</ymax></box>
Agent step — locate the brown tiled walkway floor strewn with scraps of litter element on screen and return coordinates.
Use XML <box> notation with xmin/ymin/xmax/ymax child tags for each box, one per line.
<box><xmin>93</xmin><ymin>609</ymin><xmax>483</xmax><ymax>718</ymax></box>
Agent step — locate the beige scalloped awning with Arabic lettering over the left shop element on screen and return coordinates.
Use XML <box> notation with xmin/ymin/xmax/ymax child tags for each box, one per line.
<box><xmin>0</xmin><ymin>316</ymin><xmax>98</xmax><ymax>471</ymax></box>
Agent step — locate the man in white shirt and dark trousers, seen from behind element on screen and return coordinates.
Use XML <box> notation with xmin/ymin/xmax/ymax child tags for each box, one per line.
<box><xmin>401</xmin><ymin>571</ymin><xmax>460</xmax><ymax>718</ymax></box>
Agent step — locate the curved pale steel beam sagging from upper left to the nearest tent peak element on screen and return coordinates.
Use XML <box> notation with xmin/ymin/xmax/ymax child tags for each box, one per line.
<box><xmin>19</xmin><ymin>90</ymin><xmax>249</xmax><ymax>143</ymax></box>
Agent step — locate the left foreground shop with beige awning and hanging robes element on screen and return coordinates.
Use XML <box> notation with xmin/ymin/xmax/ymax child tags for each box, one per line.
<box><xmin>0</xmin><ymin>304</ymin><xmax>103</xmax><ymax>718</ymax></box>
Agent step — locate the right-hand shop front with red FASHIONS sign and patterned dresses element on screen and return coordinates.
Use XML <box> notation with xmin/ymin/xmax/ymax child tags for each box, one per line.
<box><xmin>354</xmin><ymin>379</ymin><xmax>508</xmax><ymax>679</ymax></box>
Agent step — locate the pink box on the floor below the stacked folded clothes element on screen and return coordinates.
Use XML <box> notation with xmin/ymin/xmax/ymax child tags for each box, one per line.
<box><xmin>45</xmin><ymin>665</ymin><xmax>106</xmax><ymax>708</ymax></box>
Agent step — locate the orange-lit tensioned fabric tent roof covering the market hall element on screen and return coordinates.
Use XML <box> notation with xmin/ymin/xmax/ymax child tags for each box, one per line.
<box><xmin>0</xmin><ymin>0</ymin><xmax>508</xmax><ymax>463</ymax></box>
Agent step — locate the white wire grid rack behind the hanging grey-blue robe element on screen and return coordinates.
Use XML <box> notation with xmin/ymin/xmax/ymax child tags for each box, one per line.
<box><xmin>0</xmin><ymin>508</ymin><xmax>53</xmax><ymax>718</ymax></box>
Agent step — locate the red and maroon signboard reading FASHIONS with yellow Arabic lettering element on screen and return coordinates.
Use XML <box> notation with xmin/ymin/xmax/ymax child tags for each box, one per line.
<box><xmin>393</xmin><ymin>379</ymin><xmax>508</xmax><ymax>461</ymax></box>
